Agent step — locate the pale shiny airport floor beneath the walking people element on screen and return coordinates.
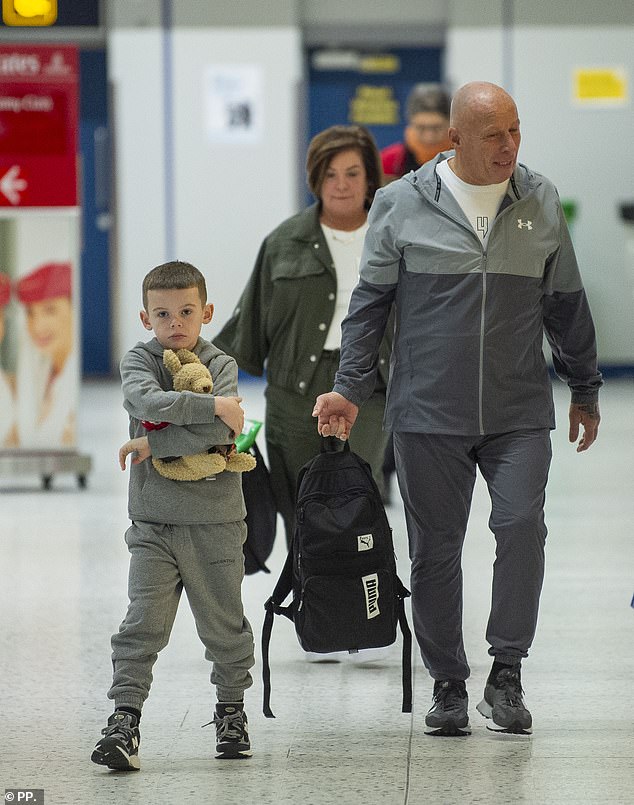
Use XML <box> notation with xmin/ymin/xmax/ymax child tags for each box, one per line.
<box><xmin>0</xmin><ymin>379</ymin><xmax>634</xmax><ymax>805</ymax></box>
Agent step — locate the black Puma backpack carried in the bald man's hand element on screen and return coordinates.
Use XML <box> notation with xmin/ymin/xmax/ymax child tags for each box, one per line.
<box><xmin>262</xmin><ymin>437</ymin><xmax>412</xmax><ymax>718</ymax></box>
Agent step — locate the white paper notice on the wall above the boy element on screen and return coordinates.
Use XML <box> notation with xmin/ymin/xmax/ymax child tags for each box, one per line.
<box><xmin>205</xmin><ymin>64</ymin><xmax>264</xmax><ymax>143</ymax></box>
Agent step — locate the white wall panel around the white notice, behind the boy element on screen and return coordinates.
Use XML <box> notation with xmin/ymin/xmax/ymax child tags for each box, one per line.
<box><xmin>173</xmin><ymin>28</ymin><xmax>301</xmax><ymax>337</ymax></box>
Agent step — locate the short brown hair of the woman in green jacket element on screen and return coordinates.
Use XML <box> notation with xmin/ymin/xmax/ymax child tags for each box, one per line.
<box><xmin>306</xmin><ymin>126</ymin><xmax>383</xmax><ymax>208</ymax></box>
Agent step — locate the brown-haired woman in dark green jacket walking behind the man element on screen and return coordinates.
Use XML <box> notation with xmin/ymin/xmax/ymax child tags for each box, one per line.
<box><xmin>214</xmin><ymin>126</ymin><xmax>391</xmax><ymax>544</ymax></box>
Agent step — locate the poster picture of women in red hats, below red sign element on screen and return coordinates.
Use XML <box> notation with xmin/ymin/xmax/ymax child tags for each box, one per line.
<box><xmin>0</xmin><ymin>212</ymin><xmax>79</xmax><ymax>450</ymax></box>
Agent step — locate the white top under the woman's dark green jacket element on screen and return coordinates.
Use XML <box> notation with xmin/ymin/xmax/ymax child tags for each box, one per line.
<box><xmin>321</xmin><ymin>221</ymin><xmax>368</xmax><ymax>349</ymax></box>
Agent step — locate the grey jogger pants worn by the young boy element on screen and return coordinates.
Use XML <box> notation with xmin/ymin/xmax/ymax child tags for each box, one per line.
<box><xmin>108</xmin><ymin>520</ymin><xmax>255</xmax><ymax>710</ymax></box>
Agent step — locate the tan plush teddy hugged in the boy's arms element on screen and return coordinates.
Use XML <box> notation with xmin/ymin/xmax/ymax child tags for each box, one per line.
<box><xmin>146</xmin><ymin>349</ymin><xmax>256</xmax><ymax>481</ymax></box>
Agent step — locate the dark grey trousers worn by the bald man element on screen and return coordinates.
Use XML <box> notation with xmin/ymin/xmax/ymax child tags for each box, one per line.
<box><xmin>394</xmin><ymin>429</ymin><xmax>552</xmax><ymax>680</ymax></box>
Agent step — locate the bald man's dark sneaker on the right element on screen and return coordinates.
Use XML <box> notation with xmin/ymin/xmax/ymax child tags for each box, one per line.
<box><xmin>477</xmin><ymin>665</ymin><xmax>533</xmax><ymax>735</ymax></box>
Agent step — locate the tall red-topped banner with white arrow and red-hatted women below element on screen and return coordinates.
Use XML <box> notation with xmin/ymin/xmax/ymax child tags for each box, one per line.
<box><xmin>0</xmin><ymin>46</ymin><xmax>79</xmax><ymax>451</ymax></box>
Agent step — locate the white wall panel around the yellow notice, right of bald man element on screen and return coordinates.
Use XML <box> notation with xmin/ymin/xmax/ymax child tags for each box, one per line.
<box><xmin>513</xmin><ymin>26</ymin><xmax>634</xmax><ymax>364</ymax></box>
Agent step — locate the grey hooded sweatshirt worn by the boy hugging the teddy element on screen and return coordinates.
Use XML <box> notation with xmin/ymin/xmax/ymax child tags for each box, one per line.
<box><xmin>120</xmin><ymin>338</ymin><xmax>246</xmax><ymax>525</ymax></box>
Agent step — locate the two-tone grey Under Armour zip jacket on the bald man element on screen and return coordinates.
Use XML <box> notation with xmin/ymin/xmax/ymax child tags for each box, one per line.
<box><xmin>334</xmin><ymin>152</ymin><xmax>602</xmax><ymax>435</ymax></box>
